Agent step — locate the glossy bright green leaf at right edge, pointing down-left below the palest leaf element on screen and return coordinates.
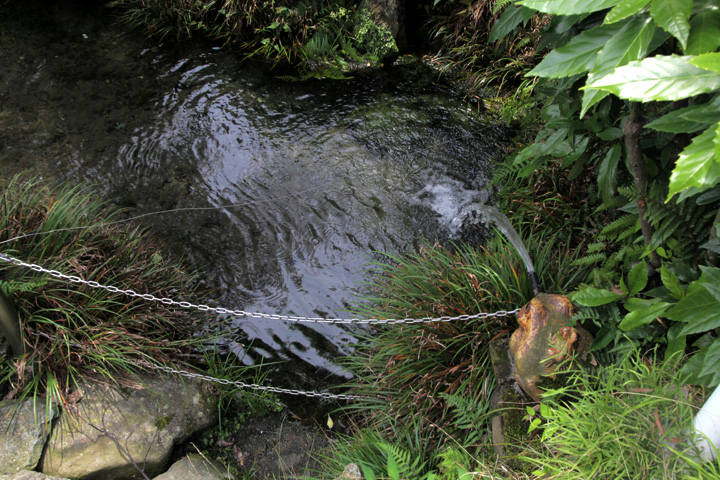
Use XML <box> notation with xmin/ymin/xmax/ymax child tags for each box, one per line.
<box><xmin>667</xmin><ymin>123</ymin><xmax>720</xmax><ymax>200</ymax></box>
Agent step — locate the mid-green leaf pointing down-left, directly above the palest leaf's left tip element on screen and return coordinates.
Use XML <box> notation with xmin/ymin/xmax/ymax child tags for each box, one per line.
<box><xmin>526</xmin><ymin>25</ymin><xmax>622</xmax><ymax>78</ymax></box>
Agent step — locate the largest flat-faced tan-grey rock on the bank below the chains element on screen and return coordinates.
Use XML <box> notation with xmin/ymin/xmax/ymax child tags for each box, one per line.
<box><xmin>41</xmin><ymin>376</ymin><xmax>217</xmax><ymax>480</ymax></box>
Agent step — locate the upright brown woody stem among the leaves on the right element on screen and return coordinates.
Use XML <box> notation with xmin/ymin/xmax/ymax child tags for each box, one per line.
<box><xmin>623</xmin><ymin>102</ymin><xmax>660</xmax><ymax>268</ymax></box>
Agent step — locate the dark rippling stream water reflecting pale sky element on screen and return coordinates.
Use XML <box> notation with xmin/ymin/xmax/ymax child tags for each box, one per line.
<box><xmin>0</xmin><ymin>2</ymin><xmax>503</xmax><ymax>384</ymax></box>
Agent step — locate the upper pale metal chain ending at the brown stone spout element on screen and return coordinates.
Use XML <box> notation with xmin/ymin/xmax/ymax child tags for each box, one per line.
<box><xmin>0</xmin><ymin>253</ymin><xmax>520</xmax><ymax>325</ymax></box>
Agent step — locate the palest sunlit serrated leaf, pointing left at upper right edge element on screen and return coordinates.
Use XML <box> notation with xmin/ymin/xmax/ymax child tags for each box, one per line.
<box><xmin>583</xmin><ymin>55</ymin><xmax>720</xmax><ymax>102</ymax></box>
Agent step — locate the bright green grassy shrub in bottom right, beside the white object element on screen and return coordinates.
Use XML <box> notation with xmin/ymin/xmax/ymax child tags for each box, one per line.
<box><xmin>526</xmin><ymin>350</ymin><xmax>720</xmax><ymax>480</ymax></box>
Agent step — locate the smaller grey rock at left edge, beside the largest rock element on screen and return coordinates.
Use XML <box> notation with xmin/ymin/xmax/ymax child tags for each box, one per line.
<box><xmin>0</xmin><ymin>398</ymin><xmax>57</xmax><ymax>474</ymax></box>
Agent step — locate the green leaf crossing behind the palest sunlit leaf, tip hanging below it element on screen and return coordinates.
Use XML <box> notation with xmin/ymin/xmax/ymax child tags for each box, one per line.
<box><xmin>580</xmin><ymin>17</ymin><xmax>657</xmax><ymax>117</ymax></box>
